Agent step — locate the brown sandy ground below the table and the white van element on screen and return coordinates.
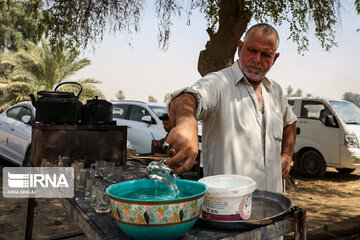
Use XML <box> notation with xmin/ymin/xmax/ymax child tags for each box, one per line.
<box><xmin>0</xmin><ymin>160</ymin><xmax>360</xmax><ymax>240</ymax></box>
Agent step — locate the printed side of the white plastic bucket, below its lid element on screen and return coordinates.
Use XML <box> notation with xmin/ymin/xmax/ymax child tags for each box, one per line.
<box><xmin>202</xmin><ymin>194</ymin><xmax>252</xmax><ymax>221</ymax></box>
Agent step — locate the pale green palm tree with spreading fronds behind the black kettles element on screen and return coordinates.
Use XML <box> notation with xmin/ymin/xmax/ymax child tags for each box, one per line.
<box><xmin>0</xmin><ymin>40</ymin><xmax>104</xmax><ymax>111</ymax></box>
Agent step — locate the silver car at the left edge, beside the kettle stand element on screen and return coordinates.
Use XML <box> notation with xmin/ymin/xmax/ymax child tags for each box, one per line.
<box><xmin>0</xmin><ymin>102</ymin><xmax>35</xmax><ymax>166</ymax></box>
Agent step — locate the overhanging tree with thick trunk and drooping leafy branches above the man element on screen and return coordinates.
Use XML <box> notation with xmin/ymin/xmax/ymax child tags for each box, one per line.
<box><xmin>0</xmin><ymin>0</ymin><xmax>360</xmax><ymax>75</ymax></box>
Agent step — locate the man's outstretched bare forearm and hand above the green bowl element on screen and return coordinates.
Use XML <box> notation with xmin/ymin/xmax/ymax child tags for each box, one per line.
<box><xmin>166</xmin><ymin>93</ymin><xmax>198</xmax><ymax>173</ymax></box>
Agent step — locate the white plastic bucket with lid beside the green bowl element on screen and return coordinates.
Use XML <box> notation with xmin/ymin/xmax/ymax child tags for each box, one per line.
<box><xmin>199</xmin><ymin>174</ymin><xmax>256</xmax><ymax>221</ymax></box>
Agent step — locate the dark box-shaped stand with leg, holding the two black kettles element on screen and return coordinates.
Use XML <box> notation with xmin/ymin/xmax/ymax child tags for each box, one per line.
<box><xmin>24</xmin><ymin>123</ymin><xmax>127</xmax><ymax>240</ymax></box>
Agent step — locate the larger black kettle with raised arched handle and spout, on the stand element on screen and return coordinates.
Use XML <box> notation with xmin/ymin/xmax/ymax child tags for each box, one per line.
<box><xmin>29</xmin><ymin>82</ymin><xmax>82</xmax><ymax>124</ymax></box>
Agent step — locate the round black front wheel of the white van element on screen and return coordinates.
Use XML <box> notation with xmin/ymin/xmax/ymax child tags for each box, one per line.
<box><xmin>301</xmin><ymin>150</ymin><xmax>326</xmax><ymax>177</ymax></box>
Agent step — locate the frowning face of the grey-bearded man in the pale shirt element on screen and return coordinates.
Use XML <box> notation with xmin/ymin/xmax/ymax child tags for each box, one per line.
<box><xmin>238</xmin><ymin>29</ymin><xmax>279</xmax><ymax>81</ymax></box>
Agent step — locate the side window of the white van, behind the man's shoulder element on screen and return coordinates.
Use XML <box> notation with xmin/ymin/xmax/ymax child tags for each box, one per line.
<box><xmin>300</xmin><ymin>101</ymin><xmax>331</xmax><ymax>123</ymax></box>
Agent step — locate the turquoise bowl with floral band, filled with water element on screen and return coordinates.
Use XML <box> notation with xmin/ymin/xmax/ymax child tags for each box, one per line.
<box><xmin>106</xmin><ymin>179</ymin><xmax>207</xmax><ymax>240</ymax></box>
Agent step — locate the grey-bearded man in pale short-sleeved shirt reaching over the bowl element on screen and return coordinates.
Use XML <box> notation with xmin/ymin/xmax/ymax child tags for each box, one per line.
<box><xmin>166</xmin><ymin>23</ymin><xmax>296</xmax><ymax>192</ymax></box>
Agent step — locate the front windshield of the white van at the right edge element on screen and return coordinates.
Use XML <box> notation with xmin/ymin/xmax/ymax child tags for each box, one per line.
<box><xmin>330</xmin><ymin>101</ymin><xmax>360</xmax><ymax>125</ymax></box>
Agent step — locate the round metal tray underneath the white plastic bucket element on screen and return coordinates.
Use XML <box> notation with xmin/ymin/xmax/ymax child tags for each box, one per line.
<box><xmin>198</xmin><ymin>190</ymin><xmax>292</xmax><ymax>230</ymax></box>
